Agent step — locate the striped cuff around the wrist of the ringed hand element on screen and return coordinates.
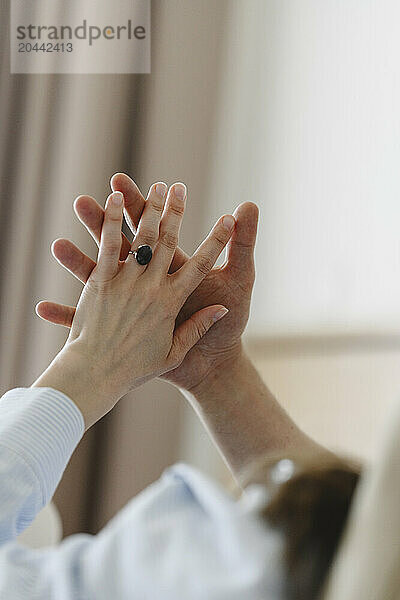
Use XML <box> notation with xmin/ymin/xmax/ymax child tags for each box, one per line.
<box><xmin>0</xmin><ymin>387</ymin><xmax>85</xmax><ymax>505</ymax></box>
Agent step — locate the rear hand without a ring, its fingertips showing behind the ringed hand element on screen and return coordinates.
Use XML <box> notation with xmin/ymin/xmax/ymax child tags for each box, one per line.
<box><xmin>36</xmin><ymin>173</ymin><xmax>258</xmax><ymax>393</ymax></box>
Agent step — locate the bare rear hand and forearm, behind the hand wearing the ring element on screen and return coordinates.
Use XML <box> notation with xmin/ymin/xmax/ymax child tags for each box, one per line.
<box><xmin>36</xmin><ymin>173</ymin><xmax>320</xmax><ymax>477</ymax></box>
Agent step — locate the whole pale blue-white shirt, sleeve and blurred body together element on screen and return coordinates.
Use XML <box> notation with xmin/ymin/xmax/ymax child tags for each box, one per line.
<box><xmin>0</xmin><ymin>388</ymin><xmax>282</xmax><ymax>600</ymax></box>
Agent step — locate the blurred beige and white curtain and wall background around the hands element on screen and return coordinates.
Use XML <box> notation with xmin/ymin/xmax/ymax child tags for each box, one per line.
<box><xmin>0</xmin><ymin>0</ymin><xmax>400</xmax><ymax>534</ymax></box>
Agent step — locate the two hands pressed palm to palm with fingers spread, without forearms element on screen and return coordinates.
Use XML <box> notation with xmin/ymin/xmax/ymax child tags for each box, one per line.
<box><xmin>34</xmin><ymin>173</ymin><xmax>258</xmax><ymax>428</ymax></box>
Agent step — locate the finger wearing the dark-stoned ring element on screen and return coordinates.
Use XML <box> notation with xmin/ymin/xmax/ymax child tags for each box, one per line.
<box><xmin>126</xmin><ymin>181</ymin><xmax>167</xmax><ymax>268</ymax></box>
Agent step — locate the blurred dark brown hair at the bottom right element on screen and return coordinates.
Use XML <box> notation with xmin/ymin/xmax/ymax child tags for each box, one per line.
<box><xmin>242</xmin><ymin>453</ymin><xmax>360</xmax><ymax>600</ymax></box>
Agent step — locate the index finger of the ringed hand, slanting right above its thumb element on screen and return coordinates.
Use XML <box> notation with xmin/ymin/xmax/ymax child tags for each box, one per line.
<box><xmin>173</xmin><ymin>215</ymin><xmax>235</xmax><ymax>300</ymax></box>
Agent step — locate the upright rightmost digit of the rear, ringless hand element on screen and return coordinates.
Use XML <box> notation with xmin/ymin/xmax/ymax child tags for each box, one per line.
<box><xmin>226</xmin><ymin>202</ymin><xmax>258</xmax><ymax>272</ymax></box>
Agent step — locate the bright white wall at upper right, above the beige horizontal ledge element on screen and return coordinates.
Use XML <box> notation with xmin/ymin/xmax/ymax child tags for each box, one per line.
<box><xmin>207</xmin><ymin>0</ymin><xmax>400</xmax><ymax>335</ymax></box>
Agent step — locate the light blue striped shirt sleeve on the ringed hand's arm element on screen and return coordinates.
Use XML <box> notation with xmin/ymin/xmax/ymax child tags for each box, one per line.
<box><xmin>0</xmin><ymin>387</ymin><xmax>84</xmax><ymax>545</ymax></box>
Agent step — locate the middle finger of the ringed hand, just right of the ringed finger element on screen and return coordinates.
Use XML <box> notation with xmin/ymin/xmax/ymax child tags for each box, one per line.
<box><xmin>151</xmin><ymin>183</ymin><xmax>186</xmax><ymax>272</ymax></box>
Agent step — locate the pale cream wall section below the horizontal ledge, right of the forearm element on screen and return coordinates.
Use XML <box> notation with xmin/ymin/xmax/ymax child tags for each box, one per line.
<box><xmin>249</xmin><ymin>342</ymin><xmax>400</xmax><ymax>461</ymax></box>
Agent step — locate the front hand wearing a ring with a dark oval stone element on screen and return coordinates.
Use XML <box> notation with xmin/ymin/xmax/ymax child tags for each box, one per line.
<box><xmin>34</xmin><ymin>183</ymin><xmax>235</xmax><ymax>427</ymax></box>
